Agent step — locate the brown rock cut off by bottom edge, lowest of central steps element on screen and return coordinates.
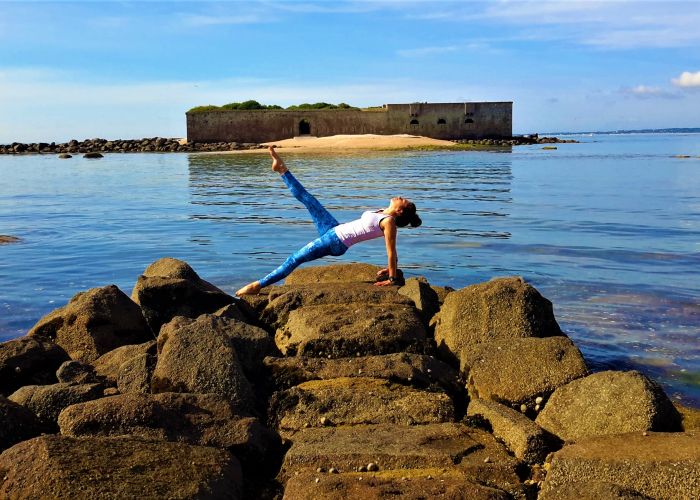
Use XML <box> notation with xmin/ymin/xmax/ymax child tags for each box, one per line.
<box><xmin>284</xmin><ymin>469</ymin><xmax>513</xmax><ymax>500</ymax></box>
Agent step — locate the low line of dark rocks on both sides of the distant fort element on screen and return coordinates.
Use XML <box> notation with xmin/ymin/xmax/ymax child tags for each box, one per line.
<box><xmin>0</xmin><ymin>135</ymin><xmax>577</xmax><ymax>155</ymax></box>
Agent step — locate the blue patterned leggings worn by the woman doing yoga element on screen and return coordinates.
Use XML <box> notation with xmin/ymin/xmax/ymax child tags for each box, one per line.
<box><xmin>260</xmin><ymin>170</ymin><xmax>348</xmax><ymax>286</ymax></box>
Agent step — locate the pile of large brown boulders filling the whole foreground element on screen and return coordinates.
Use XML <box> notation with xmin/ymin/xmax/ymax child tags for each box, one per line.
<box><xmin>0</xmin><ymin>258</ymin><xmax>700</xmax><ymax>500</ymax></box>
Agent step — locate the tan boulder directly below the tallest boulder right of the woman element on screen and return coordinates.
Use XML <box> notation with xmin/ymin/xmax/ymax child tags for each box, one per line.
<box><xmin>462</xmin><ymin>337</ymin><xmax>588</xmax><ymax>406</ymax></box>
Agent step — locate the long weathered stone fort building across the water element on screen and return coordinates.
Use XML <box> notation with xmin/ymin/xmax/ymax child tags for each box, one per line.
<box><xmin>186</xmin><ymin>102</ymin><xmax>513</xmax><ymax>143</ymax></box>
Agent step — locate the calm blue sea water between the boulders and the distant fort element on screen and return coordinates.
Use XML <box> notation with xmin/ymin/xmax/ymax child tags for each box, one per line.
<box><xmin>0</xmin><ymin>134</ymin><xmax>700</xmax><ymax>407</ymax></box>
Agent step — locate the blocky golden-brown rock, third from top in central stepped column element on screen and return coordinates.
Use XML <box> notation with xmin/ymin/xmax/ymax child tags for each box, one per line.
<box><xmin>275</xmin><ymin>303</ymin><xmax>427</xmax><ymax>358</ymax></box>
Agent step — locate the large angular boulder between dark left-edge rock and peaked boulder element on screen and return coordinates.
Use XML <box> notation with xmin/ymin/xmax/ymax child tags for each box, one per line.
<box><xmin>28</xmin><ymin>285</ymin><xmax>153</xmax><ymax>363</ymax></box>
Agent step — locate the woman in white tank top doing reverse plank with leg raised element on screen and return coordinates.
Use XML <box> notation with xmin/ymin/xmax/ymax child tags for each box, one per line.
<box><xmin>236</xmin><ymin>146</ymin><xmax>421</xmax><ymax>296</ymax></box>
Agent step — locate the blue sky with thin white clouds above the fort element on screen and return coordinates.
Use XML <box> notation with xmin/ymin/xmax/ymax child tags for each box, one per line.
<box><xmin>0</xmin><ymin>0</ymin><xmax>700</xmax><ymax>143</ymax></box>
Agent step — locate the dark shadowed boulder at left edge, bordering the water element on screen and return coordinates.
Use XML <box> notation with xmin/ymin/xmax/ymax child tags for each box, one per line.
<box><xmin>0</xmin><ymin>337</ymin><xmax>69</xmax><ymax>396</ymax></box>
